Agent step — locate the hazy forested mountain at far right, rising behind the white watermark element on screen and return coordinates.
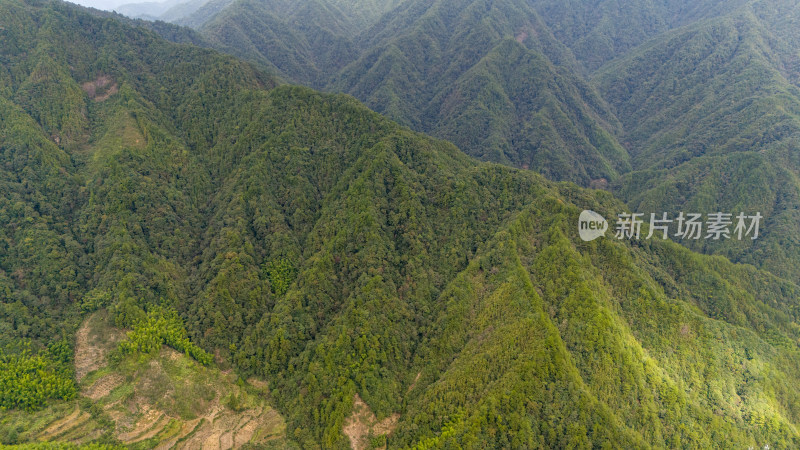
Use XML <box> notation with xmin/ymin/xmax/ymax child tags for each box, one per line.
<box><xmin>596</xmin><ymin>2</ymin><xmax>800</xmax><ymax>280</ymax></box>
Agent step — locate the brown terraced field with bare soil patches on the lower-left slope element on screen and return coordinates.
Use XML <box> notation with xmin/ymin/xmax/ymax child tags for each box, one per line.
<box><xmin>0</xmin><ymin>311</ymin><xmax>290</xmax><ymax>450</ymax></box>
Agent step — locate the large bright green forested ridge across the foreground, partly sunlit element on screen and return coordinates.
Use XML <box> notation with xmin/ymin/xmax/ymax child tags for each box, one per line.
<box><xmin>0</xmin><ymin>0</ymin><xmax>800</xmax><ymax>448</ymax></box>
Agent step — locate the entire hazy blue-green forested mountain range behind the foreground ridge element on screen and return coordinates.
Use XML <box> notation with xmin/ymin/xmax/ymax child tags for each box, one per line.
<box><xmin>138</xmin><ymin>0</ymin><xmax>800</xmax><ymax>288</ymax></box>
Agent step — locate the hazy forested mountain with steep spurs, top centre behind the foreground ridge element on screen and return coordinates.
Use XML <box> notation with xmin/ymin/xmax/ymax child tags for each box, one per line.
<box><xmin>328</xmin><ymin>0</ymin><xmax>629</xmax><ymax>185</ymax></box>
